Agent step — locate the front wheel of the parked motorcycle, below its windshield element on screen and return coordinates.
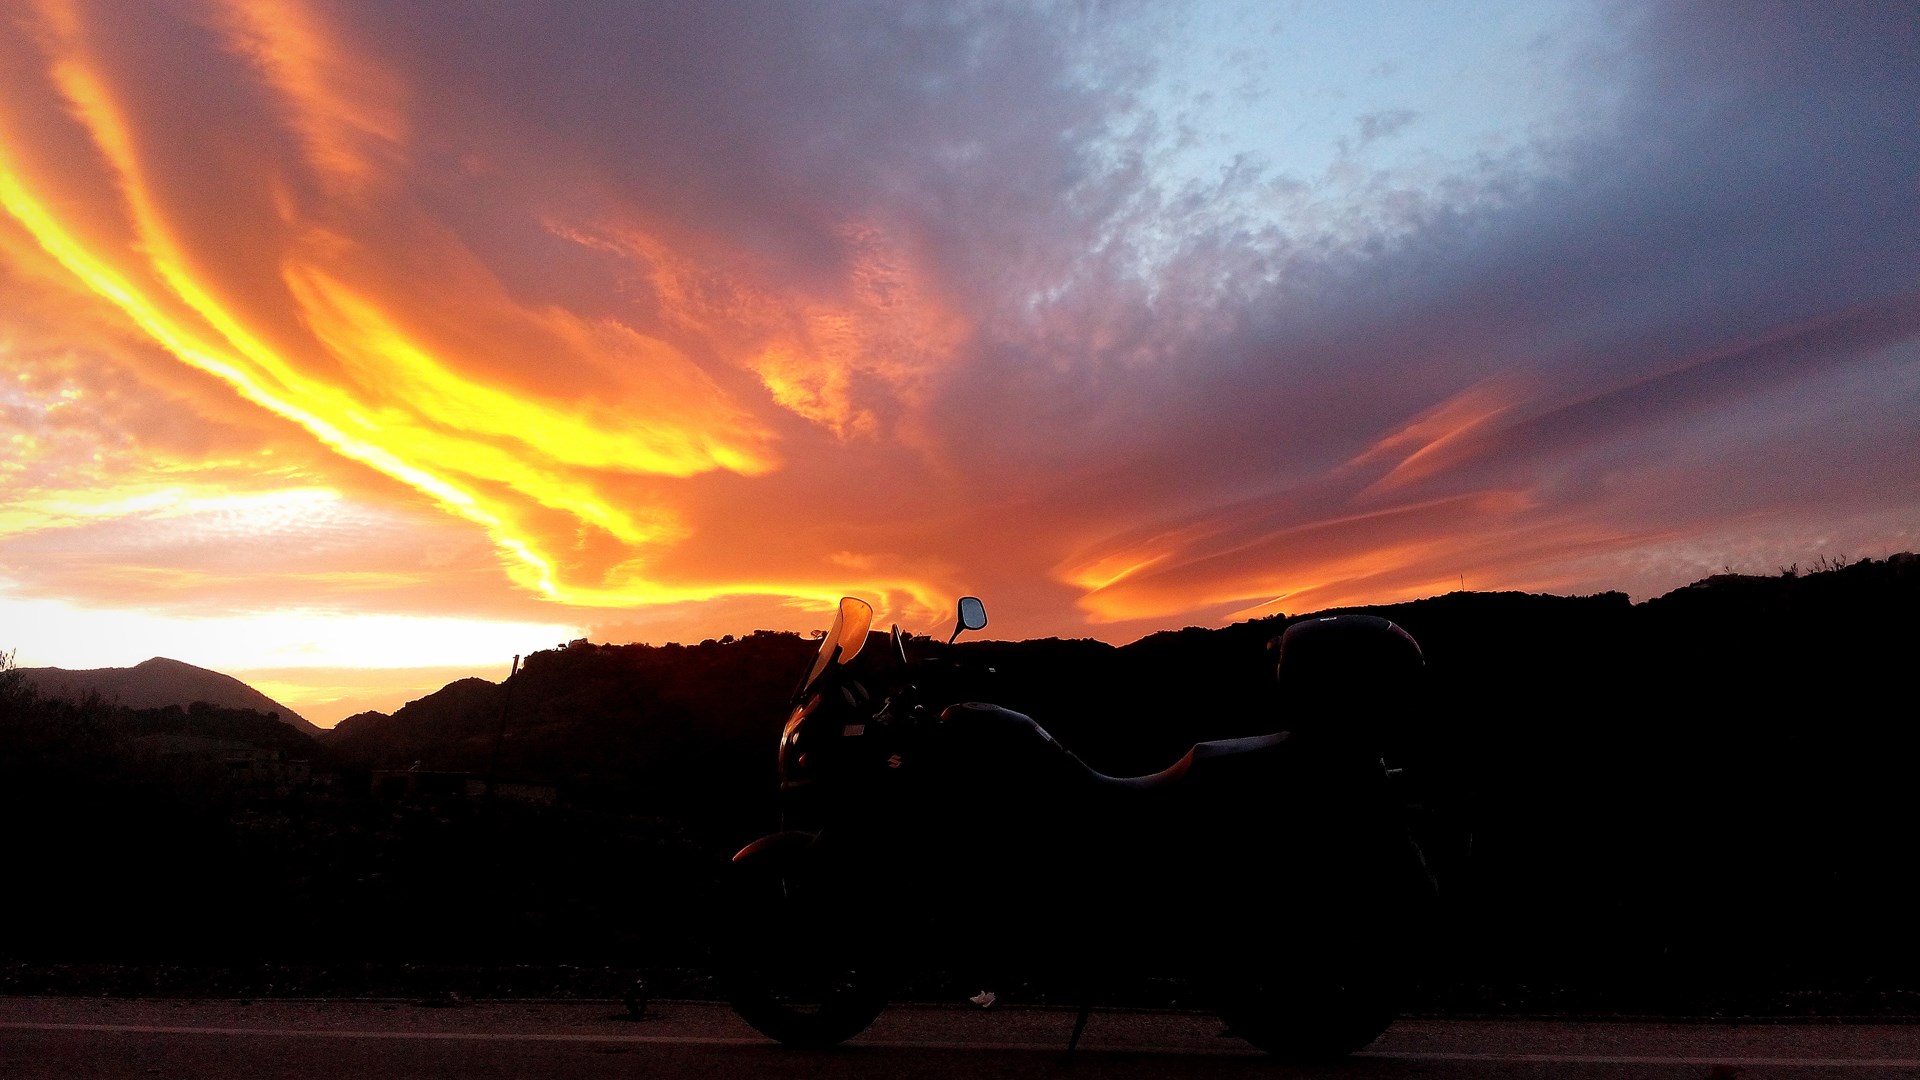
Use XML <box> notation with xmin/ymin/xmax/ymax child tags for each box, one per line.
<box><xmin>716</xmin><ymin>844</ymin><xmax>887</xmax><ymax>1047</ymax></box>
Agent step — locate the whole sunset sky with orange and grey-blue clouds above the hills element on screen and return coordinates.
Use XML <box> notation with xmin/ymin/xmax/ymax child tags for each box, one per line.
<box><xmin>0</xmin><ymin>0</ymin><xmax>1920</xmax><ymax>724</ymax></box>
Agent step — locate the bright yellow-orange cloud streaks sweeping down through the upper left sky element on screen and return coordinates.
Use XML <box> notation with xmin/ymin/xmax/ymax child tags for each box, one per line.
<box><xmin>0</xmin><ymin>4</ymin><xmax>848</xmax><ymax>605</ymax></box>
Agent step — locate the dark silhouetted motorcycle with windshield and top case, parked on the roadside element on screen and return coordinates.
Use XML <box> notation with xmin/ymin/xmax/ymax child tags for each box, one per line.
<box><xmin>716</xmin><ymin>598</ymin><xmax>1436</xmax><ymax>1061</ymax></box>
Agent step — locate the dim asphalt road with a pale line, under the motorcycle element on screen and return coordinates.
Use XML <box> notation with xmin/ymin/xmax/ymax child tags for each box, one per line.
<box><xmin>0</xmin><ymin>997</ymin><xmax>1920</xmax><ymax>1080</ymax></box>
